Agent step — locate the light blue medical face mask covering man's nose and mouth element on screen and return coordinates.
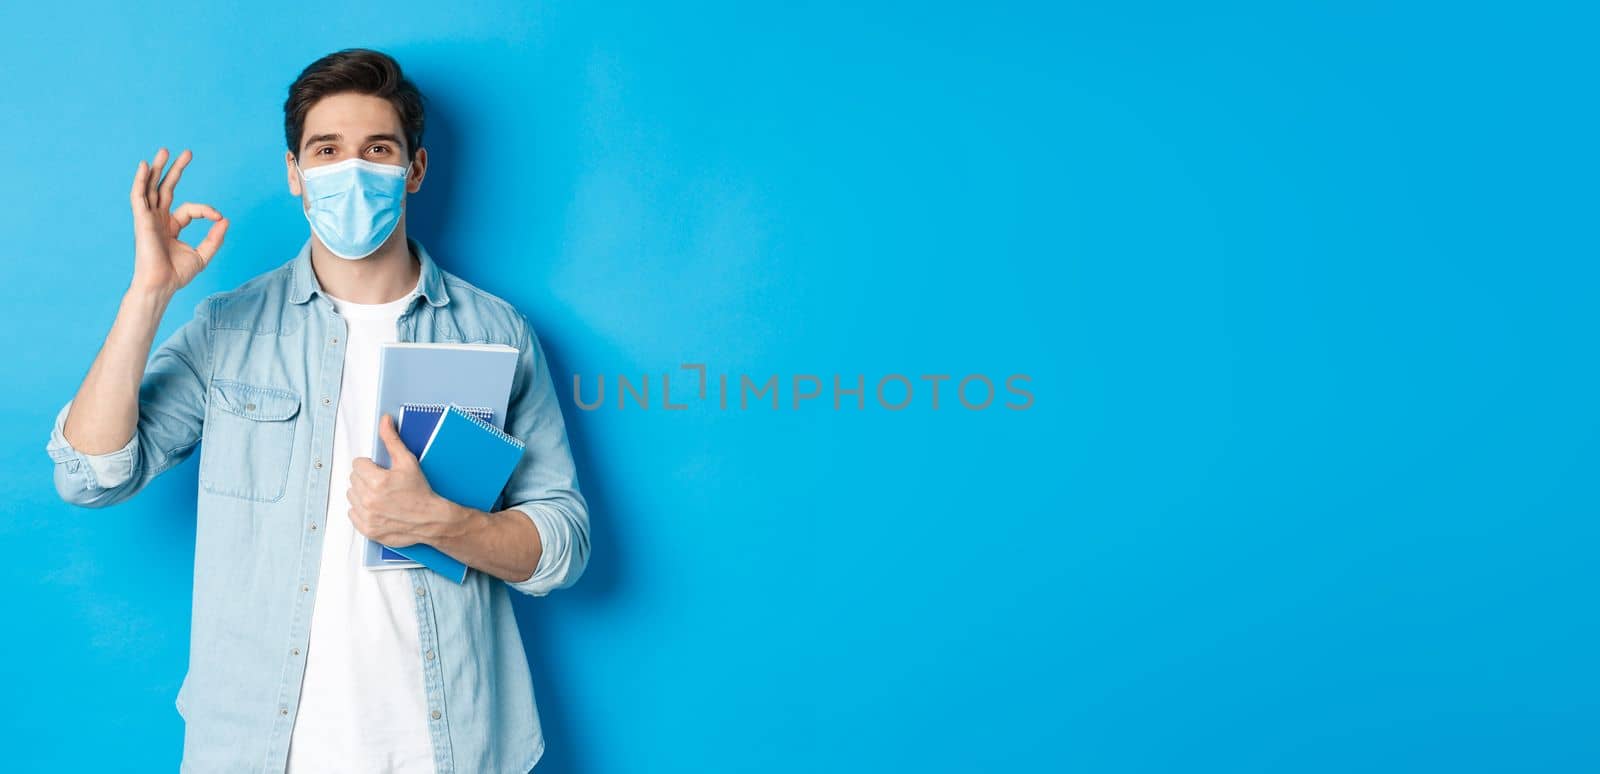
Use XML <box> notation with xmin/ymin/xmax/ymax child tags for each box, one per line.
<box><xmin>294</xmin><ymin>158</ymin><xmax>411</xmax><ymax>261</ymax></box>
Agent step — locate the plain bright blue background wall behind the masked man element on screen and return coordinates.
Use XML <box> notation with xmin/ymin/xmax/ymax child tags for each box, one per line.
<box><xmin>0</xmin><ymin>2</ymin><xmax>1600</xmax><ymax>774</ymax></box>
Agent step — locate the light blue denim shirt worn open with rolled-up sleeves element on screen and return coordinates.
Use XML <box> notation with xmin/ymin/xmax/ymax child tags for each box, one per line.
<box><xmin>46</xmin><ymin>240</ymin><xmax>589</xmax><ymax>774</ymax></box>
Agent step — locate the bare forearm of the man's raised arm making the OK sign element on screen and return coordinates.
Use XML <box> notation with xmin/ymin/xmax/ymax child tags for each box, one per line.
<box><xmin>62</xmin><ymin>288</ymin><xmax>171</xmax><ymax>454</ymax></box>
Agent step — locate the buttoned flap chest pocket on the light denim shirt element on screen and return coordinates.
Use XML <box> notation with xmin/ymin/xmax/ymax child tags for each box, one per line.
<box><xmin>200</xmin><ymin>379</ymin><xmax>301</xmax><ymax>502</ymax></box>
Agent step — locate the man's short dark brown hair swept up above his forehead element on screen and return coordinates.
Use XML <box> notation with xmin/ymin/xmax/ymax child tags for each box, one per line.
<box><xmin>283</xmin><ymin>48</ymin><xmax>422</xmax><ymax>158</ymax></box>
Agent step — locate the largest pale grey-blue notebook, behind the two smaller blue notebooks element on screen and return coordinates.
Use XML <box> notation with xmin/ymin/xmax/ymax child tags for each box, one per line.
<box><xmin>362</xmin><ymin>342</ymin><xmax>518</xmax><ymax>582</ymax></box>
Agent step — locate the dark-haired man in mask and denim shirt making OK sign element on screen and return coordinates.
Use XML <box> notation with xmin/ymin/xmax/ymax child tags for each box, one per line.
<box><xmin>48</xmin><ymin>50</ymin><xmax>589</xmax><ymax>774</ymax></box>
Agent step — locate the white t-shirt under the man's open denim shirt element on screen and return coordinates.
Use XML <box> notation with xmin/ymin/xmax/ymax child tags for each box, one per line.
<box><xmin>288</xmin><ymin>284</ymin><xmax>434</xmax><ymax>774</ymax></box>
